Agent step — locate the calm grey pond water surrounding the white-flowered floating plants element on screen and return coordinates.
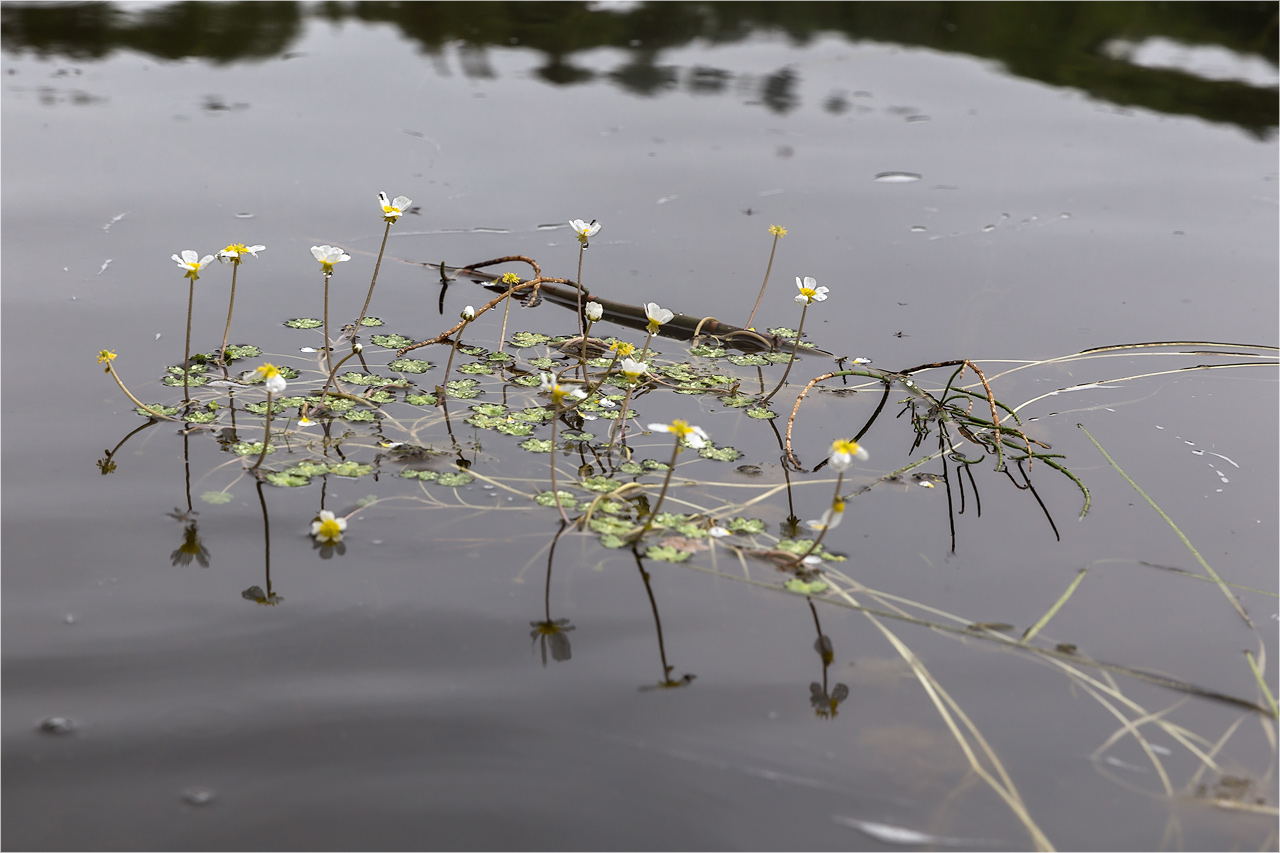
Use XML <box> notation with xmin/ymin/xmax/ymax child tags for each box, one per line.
<box><xmin>3</xmin><ymin>4</ymin><xmax>1280</xmax><ymax>849</ymax></box>
